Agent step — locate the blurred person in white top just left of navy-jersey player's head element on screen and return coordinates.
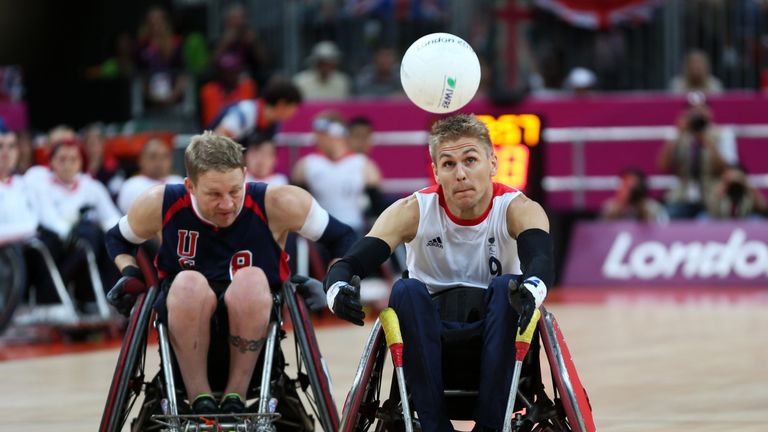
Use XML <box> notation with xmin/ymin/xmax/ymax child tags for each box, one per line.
<box><xmin>117</xmin><ymin>138</ymin><xmax>184</xmax><ymax>213</ymax></box>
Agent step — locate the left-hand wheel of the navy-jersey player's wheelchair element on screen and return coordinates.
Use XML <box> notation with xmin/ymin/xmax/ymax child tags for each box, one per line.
<box><xmin>99</xmin><ymin>286</ymin><xmax>158</xmax><ymax>432</ymax></box>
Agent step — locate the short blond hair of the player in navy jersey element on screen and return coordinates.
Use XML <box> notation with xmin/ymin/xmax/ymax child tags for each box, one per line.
<box><xmin>184</xmin><ymin>131</ymin><xmax>245</xmax><ymax>183</ymax></box>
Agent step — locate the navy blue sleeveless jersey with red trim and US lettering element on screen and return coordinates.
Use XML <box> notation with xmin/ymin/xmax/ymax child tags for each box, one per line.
<box><xmin>155</xmin><ymin>183</ymin><xmax>290</xmax><ymax>289</ymax></box>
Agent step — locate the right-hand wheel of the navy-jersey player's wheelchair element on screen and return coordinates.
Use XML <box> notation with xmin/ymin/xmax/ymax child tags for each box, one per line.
<box><xmin>284</xmin><ymin>283</ymin><xmax>339</xmax><ymax>432</ymax></box>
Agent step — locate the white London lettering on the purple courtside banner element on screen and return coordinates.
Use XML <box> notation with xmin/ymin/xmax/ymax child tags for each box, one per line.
<box><xmin>603</xmin><ymin>229</ymin><xmax>768</xmax><ymax>280</ymax></box>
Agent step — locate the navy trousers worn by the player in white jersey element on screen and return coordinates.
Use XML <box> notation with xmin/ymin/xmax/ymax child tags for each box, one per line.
<box><xmin>389</xmin><ymin>275</ymin><xmax>517</xmax><ymax>432</ymax></box>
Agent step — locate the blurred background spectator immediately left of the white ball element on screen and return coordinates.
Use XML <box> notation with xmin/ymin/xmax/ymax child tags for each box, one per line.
<box><xmin>355</xmin><ymin>47</ymin><xmax>403</xmax><ymax>97</ymax></box>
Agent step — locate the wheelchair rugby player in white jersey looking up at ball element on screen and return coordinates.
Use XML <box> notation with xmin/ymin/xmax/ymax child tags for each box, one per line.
<box><xmin>325</xmin><ymin>114</ymin><xmax>554</xmax><ymax>432</ymax></box>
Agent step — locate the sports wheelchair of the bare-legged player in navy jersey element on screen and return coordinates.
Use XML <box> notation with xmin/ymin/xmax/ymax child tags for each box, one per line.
<box><xmin>99</xmin><ymin>271</ymin><xmax>339</xmax><ymax>432</ymax></box>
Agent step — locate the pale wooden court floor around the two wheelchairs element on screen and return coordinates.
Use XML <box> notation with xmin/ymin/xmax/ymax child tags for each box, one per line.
<box><xmin>0</xmin><ymin>301</ymin><xmax>768</xmax><ymax>432</ymax></box>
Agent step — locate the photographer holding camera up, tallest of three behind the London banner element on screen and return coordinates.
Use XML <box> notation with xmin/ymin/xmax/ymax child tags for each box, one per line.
<box><xmin>659</xmin><ymin>92</ymin><xmax>737</xmax><ymax>219</ymax></box>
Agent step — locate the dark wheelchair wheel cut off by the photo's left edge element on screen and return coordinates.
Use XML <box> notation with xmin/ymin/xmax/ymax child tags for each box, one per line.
<box><xmin>0</xmin><ymin>246</ymin><xmax>27</xmax><ymax>334</ymax></box>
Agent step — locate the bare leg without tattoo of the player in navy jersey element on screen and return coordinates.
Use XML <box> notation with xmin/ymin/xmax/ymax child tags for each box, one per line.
<box><xmin>166</xmin><ymin>271</ymin><xmax>216</xmax><ymax>402</ymax></box>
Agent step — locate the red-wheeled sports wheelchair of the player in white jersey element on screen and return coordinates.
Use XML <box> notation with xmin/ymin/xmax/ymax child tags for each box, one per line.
<box><xmin>339</xmin><ymin>287</ymin><xmax>595</xmax><ymax>432</ymax></box>
